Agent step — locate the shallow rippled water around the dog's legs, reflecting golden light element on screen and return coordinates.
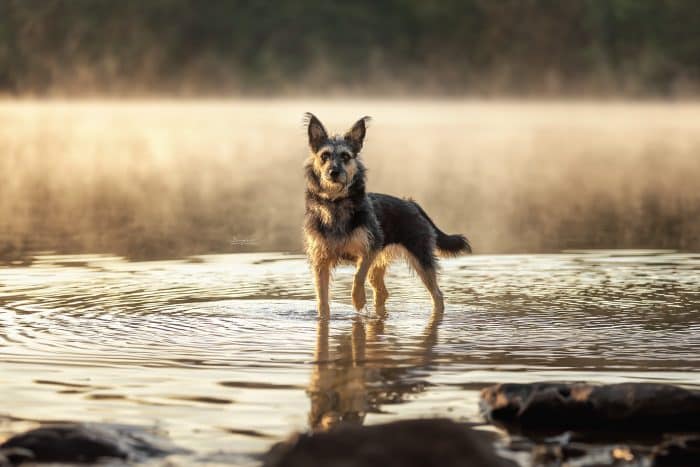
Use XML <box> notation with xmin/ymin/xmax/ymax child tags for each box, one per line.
<box><xmin>0</xmin><ymin>250</ymin><xmax>700</xmax><ymax>464</ymax></box>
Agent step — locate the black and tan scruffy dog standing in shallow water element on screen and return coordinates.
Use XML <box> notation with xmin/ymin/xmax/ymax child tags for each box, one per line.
<box><xmin>304</xmin><ymin>113</ymin><xmax>471</xmax><ymax>317</ymax></box>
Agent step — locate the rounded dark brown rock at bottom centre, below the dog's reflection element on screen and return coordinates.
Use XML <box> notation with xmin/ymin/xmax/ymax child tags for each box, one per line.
<box><xmin>264</xmin><ymin>419</ymin><xmax>517</xmax><ymax>467</ymax></box>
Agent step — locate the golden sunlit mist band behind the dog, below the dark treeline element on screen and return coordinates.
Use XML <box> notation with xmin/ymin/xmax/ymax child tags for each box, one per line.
<box><xmin>0</xmin><ymin>99</ymin><xmax>700</xmax><ymax>260</ymax></box>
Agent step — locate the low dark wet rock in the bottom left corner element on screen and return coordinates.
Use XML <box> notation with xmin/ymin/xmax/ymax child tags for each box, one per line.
<box><xmin>0</xmin><ymin>423</ymin><xmax>185</xmax><ymax>465</ymax></box>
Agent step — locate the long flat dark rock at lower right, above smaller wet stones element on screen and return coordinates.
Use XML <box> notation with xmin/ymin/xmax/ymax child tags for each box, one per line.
<box><xmin>480</xmin><ymin>383</ymin><xmax>700</xmax><ymax>433</ymax></box>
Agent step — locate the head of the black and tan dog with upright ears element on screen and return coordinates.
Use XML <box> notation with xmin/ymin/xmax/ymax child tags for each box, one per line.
<box><xmin>305</xmin><ymin>113</ymin><xmax>369</xmax><ymax>194</ymax></box>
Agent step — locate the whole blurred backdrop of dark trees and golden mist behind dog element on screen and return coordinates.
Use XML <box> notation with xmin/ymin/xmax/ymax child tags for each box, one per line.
<box><xmin>0</xmin><ymin>0</ymin><xmax>700</xmax><ymax>264</ymax></box>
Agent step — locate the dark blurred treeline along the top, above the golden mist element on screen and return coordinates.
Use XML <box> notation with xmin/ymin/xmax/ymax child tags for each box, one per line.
<box><xmin>0</xmin><ymin>0</ymin><xmax>700</xmax><ymax>96</ymax></box>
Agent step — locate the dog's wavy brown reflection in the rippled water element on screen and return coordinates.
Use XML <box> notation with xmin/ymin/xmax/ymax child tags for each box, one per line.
<box><xmin>308</xmin><ymin>310</ymin><xmax>442</xmax><ymax>430</ymax></box>
